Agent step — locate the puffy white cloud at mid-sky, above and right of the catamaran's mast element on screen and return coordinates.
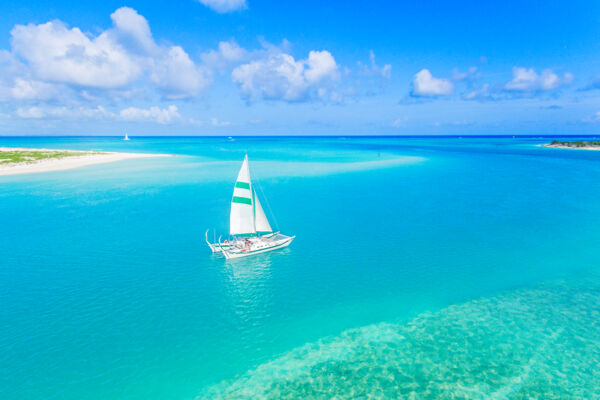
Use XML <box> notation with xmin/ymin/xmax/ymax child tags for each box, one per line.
<box><xmin>231</xmin><ymin>50</ymin><xmax>339</xmax><ymax>102</ymax></box>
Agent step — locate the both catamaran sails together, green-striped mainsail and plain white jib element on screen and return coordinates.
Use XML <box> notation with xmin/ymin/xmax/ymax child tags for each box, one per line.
<box><xmin>229</xmin><ymin>155</ymin><xmax>273</xmax><ymax>236</ymax></box>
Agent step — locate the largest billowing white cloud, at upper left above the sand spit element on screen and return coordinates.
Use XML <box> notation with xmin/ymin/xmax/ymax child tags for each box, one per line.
<box><xmin>11</xmin><ymin>7</ymin><xmax>210</xmax><ymax>98</ymax></box>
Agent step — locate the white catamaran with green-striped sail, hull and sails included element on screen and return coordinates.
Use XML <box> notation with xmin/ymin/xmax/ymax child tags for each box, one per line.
<box><xmin>205</xmin><ymin>155</ymin><xmax>296</xmax><ymax>259</ymax></box>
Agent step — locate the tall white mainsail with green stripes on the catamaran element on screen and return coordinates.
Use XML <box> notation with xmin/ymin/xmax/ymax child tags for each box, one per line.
<box><xmin>229</xmin><ymin>155</ymin><xmax>256</xmax><ymax>236</ymax></box>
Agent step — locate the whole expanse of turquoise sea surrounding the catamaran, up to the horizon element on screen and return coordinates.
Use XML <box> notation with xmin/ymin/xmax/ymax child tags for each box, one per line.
<box><xmin>0</xmin><ymin>137</ymin><xmax>600</xmax><ymax>399</ymax></box>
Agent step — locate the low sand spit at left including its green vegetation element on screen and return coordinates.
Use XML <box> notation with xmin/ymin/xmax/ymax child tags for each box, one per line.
<box><xmin>0</xmin><ymin>147</ymin><xmax>168</xmax><ymax>176</ymax></box>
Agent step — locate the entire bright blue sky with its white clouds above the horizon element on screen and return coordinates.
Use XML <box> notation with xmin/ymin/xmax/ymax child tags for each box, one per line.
<box><xmin>0</xmin><ymin>0</ymin><xmax>600</xmax><ymax>135</ymax></box>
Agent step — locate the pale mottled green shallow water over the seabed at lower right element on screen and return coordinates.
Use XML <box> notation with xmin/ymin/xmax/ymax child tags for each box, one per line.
<box><xmin>202</xmin><ymin>279</ymin><xmax>600</xmax><ymax>399</ymax></box>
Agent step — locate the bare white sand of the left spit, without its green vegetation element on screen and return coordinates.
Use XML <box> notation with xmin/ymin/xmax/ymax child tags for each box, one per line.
<box><xmin>0</xmin><ymin>147</ymin><xmax>172</xmax><ymax>176</ymax></box>
